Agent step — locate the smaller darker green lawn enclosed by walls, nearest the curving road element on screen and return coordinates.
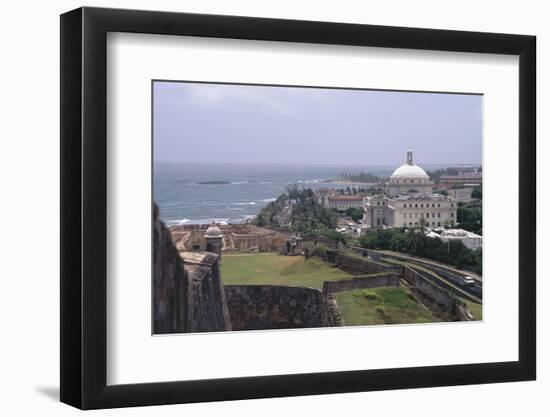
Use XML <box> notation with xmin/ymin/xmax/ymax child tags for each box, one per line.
<box><xmin>335</xmin><ymin>287</ymin><xmax>442</xmax><ymax>326</ymax></box>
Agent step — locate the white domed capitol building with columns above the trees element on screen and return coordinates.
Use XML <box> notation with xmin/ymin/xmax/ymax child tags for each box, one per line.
<box><xmin>363</xmin><ymin>151</ymin><xmax>457</xmax><ymax>230</ymax></box>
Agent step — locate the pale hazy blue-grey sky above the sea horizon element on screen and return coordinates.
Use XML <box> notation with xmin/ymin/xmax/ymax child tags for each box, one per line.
<box><xmin>153</xmin><ymin>81</ymin><xmax>483</xmax><ymax>165</ymax></box>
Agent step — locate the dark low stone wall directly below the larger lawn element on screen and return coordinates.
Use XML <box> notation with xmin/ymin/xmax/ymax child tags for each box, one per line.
<box><xmin>225</xmin><ymin>285</ymin><xmax>336</xmax><ymax>330</ymax></box>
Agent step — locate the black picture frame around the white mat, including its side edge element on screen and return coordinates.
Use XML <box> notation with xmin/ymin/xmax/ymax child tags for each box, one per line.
<box><xmin>60</xmin><ymin>7</ymin><xmax>536</xmax><ymax>409</ymax></box>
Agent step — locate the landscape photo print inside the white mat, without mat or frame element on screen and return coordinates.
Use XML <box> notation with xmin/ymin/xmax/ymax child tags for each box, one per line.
<box><xmin>152</xmin><ymin>80</ymin><xmax>483</xmax><ymax>334</ymax></box>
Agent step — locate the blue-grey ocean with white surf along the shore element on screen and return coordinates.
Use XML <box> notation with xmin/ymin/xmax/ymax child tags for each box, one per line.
<box><xmin>153</xmin><ymin>162</ymin><xmax>426</xmax><ymax>225</ymax></box>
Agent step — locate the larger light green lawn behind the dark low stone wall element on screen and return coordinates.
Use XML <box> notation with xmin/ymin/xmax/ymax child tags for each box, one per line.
<box><xmin>221</xmin><ymin>253</ymin><xmax>352</xmax><ymax>289</ymax></box>
